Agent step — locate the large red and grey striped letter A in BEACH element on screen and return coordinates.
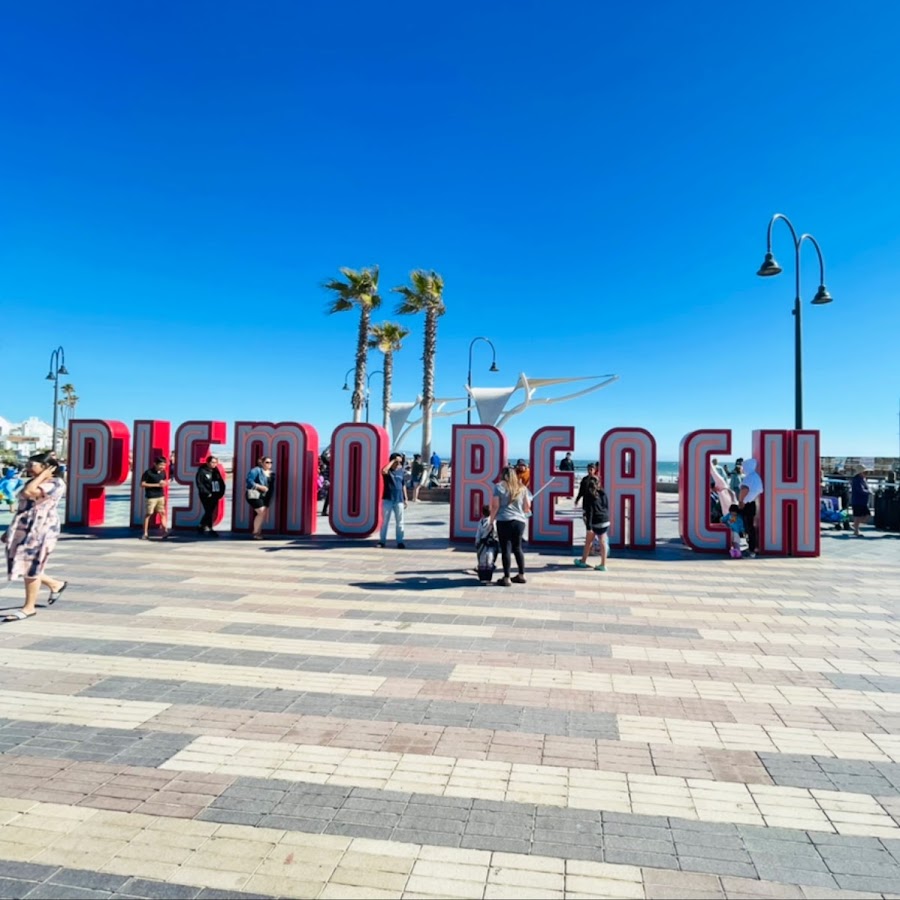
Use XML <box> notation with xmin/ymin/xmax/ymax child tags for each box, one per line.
<box><xmin>600</xmin><ymin>428</ymin><xmax>656</xmax><ymax>550</ymax></box>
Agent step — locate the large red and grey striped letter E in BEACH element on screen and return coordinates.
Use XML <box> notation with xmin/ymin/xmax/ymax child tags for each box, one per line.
<box><xmin>528</xmin><ymin>425</ymin><xmax>575</xmax><ymax>547</ymax></box>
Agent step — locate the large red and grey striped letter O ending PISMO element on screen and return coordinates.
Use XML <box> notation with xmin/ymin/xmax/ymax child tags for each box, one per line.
<box><xmin>328</xmin><ymin>422</ymin><xmax>390</xmax><ymax>537</ymax></box>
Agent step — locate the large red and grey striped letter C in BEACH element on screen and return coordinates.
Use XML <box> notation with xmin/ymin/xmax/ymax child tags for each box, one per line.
<box><xmin>678</xmin><ymin>429</ymin><xmax>731</xmax><ymax>553</ymax></box>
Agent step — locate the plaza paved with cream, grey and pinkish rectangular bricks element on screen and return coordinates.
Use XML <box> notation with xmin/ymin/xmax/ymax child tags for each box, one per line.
<box><xmin>0</xmin><ymin>498</ymin><xmax>900</xmax><ymax>898</ymax></box>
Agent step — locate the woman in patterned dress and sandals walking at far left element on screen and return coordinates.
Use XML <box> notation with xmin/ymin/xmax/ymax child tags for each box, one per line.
<box><xmin>0</xmin><ymin>453</ymin><xmax>68</xmax><ymax>622</ymax></box>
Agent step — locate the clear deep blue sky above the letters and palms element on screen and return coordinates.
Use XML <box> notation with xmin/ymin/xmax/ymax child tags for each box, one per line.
<box><xmin>0</xmin><ymin>0</ymin><xmax>900</xmax><ymax>459</ymax></box>
